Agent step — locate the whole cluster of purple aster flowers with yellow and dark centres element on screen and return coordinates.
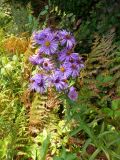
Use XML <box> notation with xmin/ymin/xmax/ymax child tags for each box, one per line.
<box><xmin>29</xmin><ymin>28</ymin><xmax>84</xmax><ymax>101</ymax></box>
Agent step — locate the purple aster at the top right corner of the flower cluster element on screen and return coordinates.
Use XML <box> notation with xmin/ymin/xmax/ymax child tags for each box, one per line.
<box><xmin>59</xmin><ymin>30</ymin><xmax>76</xmax><ymax>49</ymax></box>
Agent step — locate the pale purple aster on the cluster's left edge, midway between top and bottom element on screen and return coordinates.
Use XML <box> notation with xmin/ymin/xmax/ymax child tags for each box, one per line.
<box><xmin>29</xmin><ymin>54</ymin><xmax>43</xmax><ymax>65</ymax></box>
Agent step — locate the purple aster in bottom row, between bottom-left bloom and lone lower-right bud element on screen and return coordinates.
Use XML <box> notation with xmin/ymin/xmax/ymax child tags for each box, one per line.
<box><xmin>51</xmin><ymin>72</ymin><xmax>68</xmax><ymax>91</ymax></box>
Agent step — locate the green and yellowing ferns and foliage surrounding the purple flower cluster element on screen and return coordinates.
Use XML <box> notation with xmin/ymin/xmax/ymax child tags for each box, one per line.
<box><xmin>0</xmin><ymin>0</ymin><xmax>120</xmax><ymax>160</ymax></box>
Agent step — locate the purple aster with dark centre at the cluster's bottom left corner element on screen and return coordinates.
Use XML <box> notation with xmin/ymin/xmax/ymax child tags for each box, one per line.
<box><xmin>30</xmin><ymin>74</ymin><xmax>48</xmax><ymax>94</ymax></box>
